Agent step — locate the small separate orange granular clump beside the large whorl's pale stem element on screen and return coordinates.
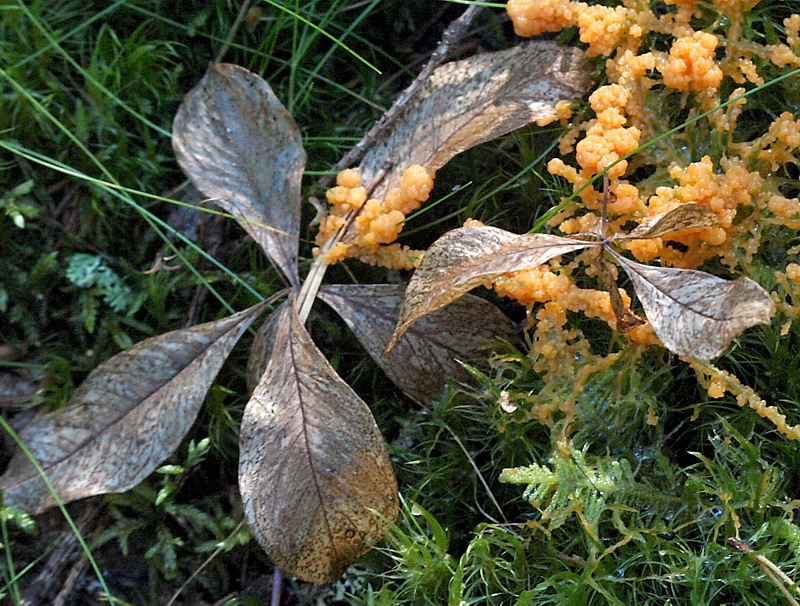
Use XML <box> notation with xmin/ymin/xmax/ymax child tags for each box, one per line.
<box><xmin>314</xmin><ymin>165</ymin><xmax>434</xmax><ymax>269</ymax></box>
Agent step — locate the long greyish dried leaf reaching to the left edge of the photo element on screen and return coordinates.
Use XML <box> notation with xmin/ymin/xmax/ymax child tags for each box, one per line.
<box><xmin>0</xmin><ymin>304</ymin><xmax>264</xmax><ymax>513</ymax></box>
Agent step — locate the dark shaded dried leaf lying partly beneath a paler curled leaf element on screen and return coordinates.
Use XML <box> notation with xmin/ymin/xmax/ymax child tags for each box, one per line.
<box><xmin>319</xmin><ymin>284</ymin><xmax>517</xmax><ymax>402</ymax></box>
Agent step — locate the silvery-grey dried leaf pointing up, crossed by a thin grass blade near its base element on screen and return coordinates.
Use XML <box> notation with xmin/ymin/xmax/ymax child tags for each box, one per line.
<box><xmin>172</xmin><ymin>63</ymin><xmax>306</xmax><ymax>286</ymax></box>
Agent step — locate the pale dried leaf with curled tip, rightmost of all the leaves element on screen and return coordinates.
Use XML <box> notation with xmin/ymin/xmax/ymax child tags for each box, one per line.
<box><xmin>609</xmin><ymin>249</ymin><xmax>775</xmax><ymax>360</ymax></box>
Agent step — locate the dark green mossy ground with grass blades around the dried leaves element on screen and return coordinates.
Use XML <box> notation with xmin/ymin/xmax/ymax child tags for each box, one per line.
<box><xmin>0</xmin><ymin>0</ymin><xmax>800</xmax><ymax>605</ymax></box>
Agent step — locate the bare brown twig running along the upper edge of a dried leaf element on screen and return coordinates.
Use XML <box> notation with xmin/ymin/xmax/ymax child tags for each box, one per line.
<box><xmin>318</xmin><ymin>6</ymin><xmax>482</xmax><ymax>188</ymax></box>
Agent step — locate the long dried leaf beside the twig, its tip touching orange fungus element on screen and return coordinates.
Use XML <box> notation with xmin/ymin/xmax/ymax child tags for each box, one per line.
<box><xmin>361</xmin><ymin>40</ymin><xmax>591</xmax><ymax>198</ymax></box>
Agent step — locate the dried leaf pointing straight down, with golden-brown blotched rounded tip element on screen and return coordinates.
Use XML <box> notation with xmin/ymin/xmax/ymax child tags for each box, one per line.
<box><xmin>239</xmin><ymin>300</ymin><xmax>398</xmax><ymax>583</ymax></box>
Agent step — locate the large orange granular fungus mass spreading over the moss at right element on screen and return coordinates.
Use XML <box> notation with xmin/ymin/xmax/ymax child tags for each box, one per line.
<box><xmin>504</xmin><ymin>0</ymin><xmax>800</xmax><ymax>408</ymax></box>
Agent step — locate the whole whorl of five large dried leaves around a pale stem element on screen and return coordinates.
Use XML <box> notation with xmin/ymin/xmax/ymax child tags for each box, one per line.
<box><xmin>0</xmin><ymin>42</ymin><xmax>589</xmax><ymax>582</ymax></box>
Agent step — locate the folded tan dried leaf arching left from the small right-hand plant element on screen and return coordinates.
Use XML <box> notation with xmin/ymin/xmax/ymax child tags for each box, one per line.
<box><xmin>389</xmin><ymin>226</ymin><xmax>599</xmax><ymax>348</ymax></box>
